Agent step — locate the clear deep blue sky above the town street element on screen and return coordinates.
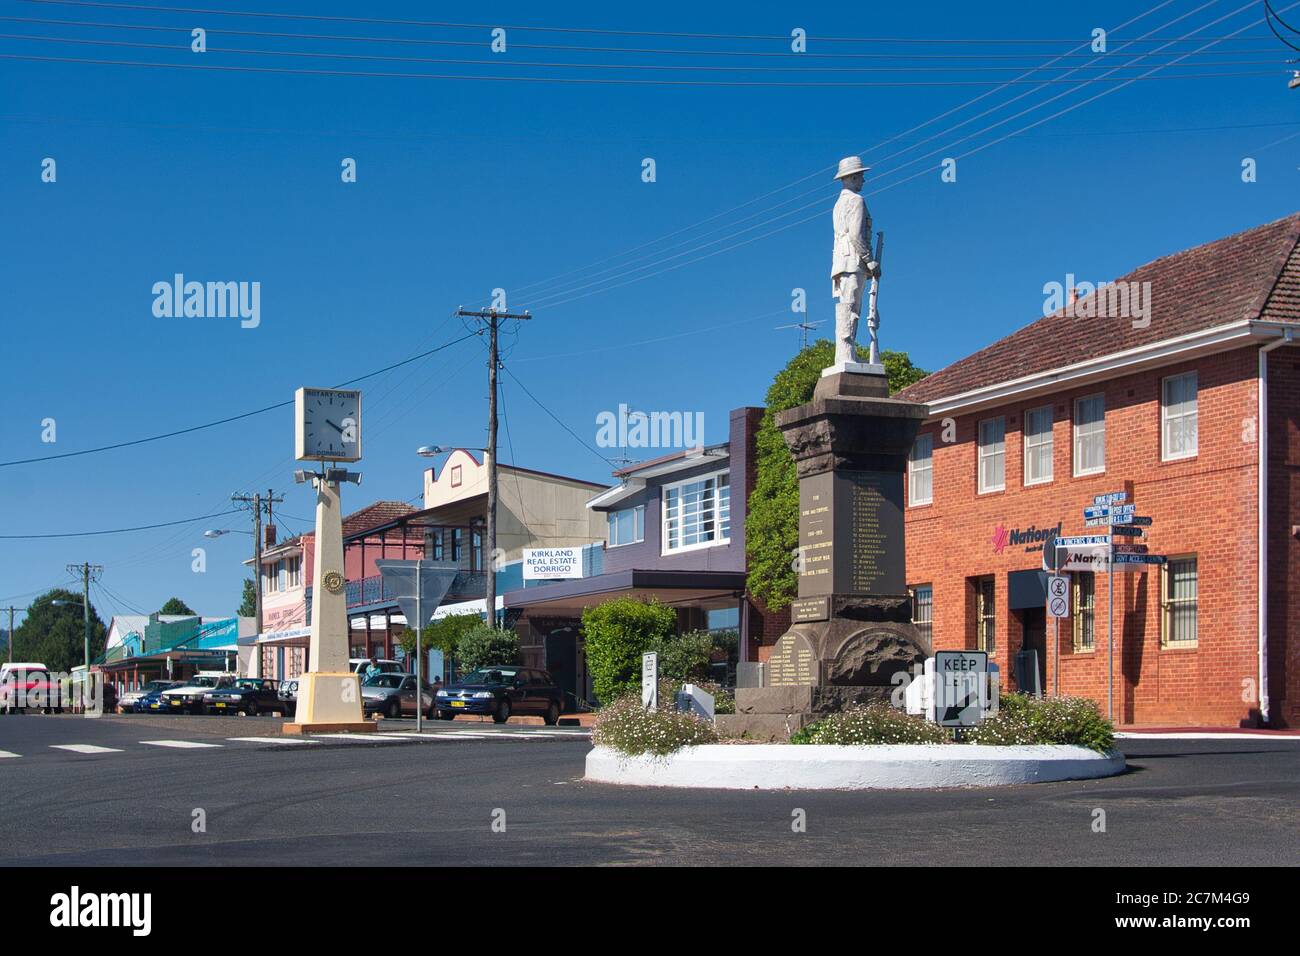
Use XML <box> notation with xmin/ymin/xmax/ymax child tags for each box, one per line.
<box><xmin>0</xmin><ymin>0</ymin><xmax>1300</xmax><ymax>618</ymax></box>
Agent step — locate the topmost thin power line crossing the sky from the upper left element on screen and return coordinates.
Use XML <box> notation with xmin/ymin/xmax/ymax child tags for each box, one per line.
<box><xmin>26</xmin><ymin>0</ymin><xmax>1289</xmax><ymax>44</ymax></box>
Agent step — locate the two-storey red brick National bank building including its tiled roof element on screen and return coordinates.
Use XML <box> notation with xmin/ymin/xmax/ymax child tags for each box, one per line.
<box><xmin>900</xmin><ymin>213</ymin><xmax>1300</xmax><ymax>727</ymax></box>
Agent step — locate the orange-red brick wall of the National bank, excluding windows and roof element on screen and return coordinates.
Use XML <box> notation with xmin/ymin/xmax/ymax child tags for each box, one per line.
<box><xmin>906</xmin><ymin>349</ymin><xmax>1284</xmax><ymax>726</ymax></box>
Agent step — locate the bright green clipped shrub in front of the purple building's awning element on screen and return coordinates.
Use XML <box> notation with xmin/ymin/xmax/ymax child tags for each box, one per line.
<box><xmin>582</xmin><ymin>597</ymin><xmax>677</xmax><ymax>702</ymax></box>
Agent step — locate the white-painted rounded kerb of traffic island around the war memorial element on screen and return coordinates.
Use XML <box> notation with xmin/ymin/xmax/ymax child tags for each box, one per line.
<box><xmin>585</xmin><ymin>744</ymin><xmax>1125</xmax><ymax>790</ymax></box>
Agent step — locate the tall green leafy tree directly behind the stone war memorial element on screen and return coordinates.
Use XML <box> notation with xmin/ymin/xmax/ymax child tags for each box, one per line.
<box><xmin>745</xmin><ymin>338</ymin><xmax>930</xmax><ymax>610</ymax></box>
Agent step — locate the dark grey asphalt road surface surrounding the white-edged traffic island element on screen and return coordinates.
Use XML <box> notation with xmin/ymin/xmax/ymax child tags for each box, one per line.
<box><xmin>0</xmin><ymin>715</ymin><xmax>1300</xmax><ymax>866</ymax></box>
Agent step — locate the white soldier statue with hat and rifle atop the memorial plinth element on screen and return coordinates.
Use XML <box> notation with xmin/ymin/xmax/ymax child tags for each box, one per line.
<box><xmin>823</xmin><ymin>156</ymin><xmax>883</xmax><ymax>375</ymax></box>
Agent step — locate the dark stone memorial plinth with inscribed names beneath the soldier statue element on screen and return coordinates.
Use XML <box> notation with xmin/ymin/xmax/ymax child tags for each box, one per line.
<box><xmin>718</xmin><ymin>369</ymin><xmax>930</xmax><ymax>739</ymax></box>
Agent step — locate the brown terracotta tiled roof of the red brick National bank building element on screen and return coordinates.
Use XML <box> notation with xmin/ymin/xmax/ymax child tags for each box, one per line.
<box><xmin>896</xmin><ymin>213</ymin><xmax>1300</xmax><ymax>402</ymax></box>
